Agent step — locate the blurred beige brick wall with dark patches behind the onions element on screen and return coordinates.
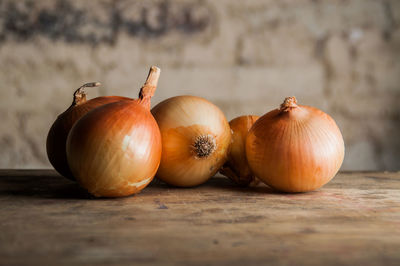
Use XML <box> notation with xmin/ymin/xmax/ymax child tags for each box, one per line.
<box><xmin>0</xmin><ymin>0</ymin><xmax>400</xmax><ymax>170</ymax></box>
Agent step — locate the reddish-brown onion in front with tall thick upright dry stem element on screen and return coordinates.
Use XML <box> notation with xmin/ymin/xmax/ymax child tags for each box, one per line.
<box><xmin>67</xmin><ymin>67</ymin><xmax>161</xmax><ymax>197</ymax></box>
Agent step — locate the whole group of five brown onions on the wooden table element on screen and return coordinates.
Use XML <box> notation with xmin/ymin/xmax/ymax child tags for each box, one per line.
<box><xmin>46</xmin><ymin>66</ymin><xmax>344</xmax><ymax>197</ymax></box>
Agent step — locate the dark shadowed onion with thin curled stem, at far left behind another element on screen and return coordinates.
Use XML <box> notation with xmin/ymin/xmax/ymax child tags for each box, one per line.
<box><xmin>46</xmin><ymin>82</ymin><xmax>129</xmax><ymax>180</ymax></box>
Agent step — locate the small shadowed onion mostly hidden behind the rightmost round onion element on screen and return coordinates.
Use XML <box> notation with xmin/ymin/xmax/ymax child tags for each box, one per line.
<box><xmin>220</xmin><ymin>115</ymin><xmax>259</xmax><ymax>186</ymax></box>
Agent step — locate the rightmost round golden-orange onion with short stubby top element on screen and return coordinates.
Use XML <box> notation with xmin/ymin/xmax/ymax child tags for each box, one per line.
<box><xmin>246</xmin><ymin>97</ymin><xmax>344</xmax><ymax>192</ymax></box>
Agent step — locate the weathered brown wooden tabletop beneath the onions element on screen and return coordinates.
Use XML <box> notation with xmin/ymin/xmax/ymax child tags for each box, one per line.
<box><xmin>0</xmin><ymin>170</ymin><xmax>400</xmax><ymax>265</ymax></box>
